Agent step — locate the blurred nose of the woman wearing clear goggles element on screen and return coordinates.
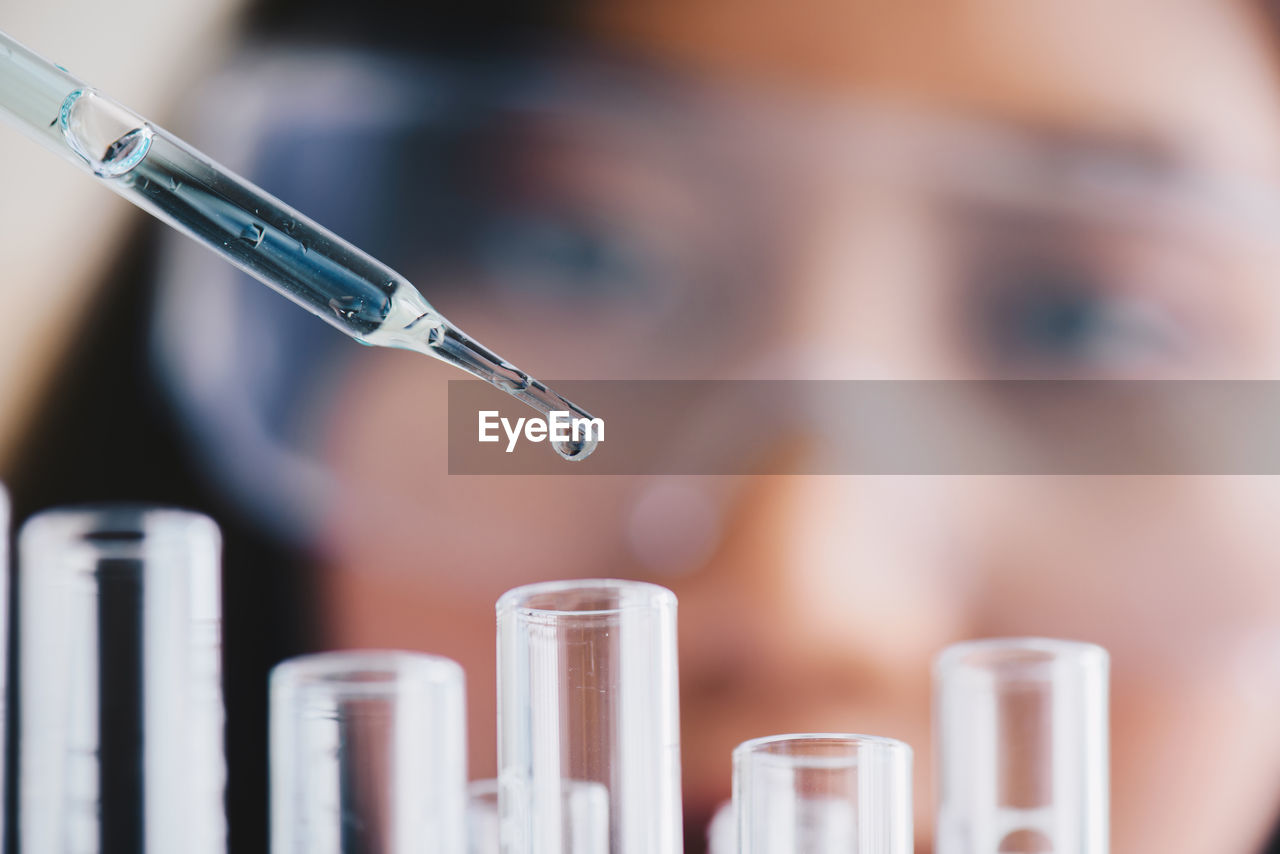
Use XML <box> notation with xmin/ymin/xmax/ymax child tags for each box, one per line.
<box><xmin>682</xmin><ymin>183</ymin><xmax>965</xmax><ymax>696</ymax></box>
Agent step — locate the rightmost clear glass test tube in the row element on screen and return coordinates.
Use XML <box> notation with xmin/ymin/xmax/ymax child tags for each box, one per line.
<box><xmin>934</xmin><ymin>638</ymin><xmax>1110</xmax><ymax>854</ymax></box>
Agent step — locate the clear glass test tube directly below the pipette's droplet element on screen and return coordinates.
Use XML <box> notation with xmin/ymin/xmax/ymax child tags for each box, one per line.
<box><xmin>498</xmin><ymin>580</ymin><xmax>682</xmax><ymax>854</ymax></box>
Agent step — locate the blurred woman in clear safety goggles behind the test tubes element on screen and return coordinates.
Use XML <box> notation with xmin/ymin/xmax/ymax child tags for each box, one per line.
<box><xmin>13</xmin><ymin>0</ymin><xmax>1280</xmax><ymax>854</ymax></box>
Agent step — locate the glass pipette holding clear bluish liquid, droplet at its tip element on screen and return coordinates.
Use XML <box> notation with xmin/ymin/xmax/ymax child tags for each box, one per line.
<box><xmin>0</xmin><ymin>32</ymin><xmax>595</xmax><ymax>460</ymax></box>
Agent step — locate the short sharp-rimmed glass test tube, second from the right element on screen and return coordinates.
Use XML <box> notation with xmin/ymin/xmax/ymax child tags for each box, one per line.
<box><xmin>733</xmin><ymin>734</ymin><xmax>913</xmax><ymax>854</ymax></box>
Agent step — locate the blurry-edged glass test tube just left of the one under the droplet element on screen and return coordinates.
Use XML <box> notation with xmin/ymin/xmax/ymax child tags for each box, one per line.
<box><xmin>271</xmin><ymin>650</ymin><xmax>467</xmax><ymax>854</ymax></box>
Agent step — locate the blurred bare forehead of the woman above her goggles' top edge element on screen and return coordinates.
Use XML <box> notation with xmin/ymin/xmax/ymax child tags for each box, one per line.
<box><xmin>590</xmin><ymin>0</ymin><xmax>1280</xmax><ymax>181</ymax></box>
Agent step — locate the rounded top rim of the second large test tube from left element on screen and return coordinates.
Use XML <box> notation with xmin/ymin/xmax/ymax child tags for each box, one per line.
<box><xmin>271</xmin><ymin>649</ymin><xmax>465</xmax><ymax>697</ymax></box>
